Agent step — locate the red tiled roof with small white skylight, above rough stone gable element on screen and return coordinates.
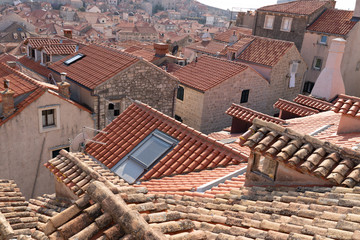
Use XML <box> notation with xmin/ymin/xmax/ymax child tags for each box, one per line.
<box><xmin>49</xmin><ymin>45</ymin><xmax>139</xmax><ymax>89</ymax></box>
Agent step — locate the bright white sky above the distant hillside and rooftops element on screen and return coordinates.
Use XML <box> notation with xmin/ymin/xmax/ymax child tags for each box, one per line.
<box><xmin>198</xmin><ymin>0</ymin><xmax>356</xmax><ymax>11</ymax></box>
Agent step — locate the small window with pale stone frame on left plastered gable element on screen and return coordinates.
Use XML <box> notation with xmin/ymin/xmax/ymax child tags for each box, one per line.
<box><xmin>39</xmin><ymin>105</ymin><xmax>60</xmax><ymax>133</ymax></box>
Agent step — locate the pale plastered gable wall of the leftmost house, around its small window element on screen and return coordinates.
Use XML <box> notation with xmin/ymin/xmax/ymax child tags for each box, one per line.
<box><xmin>0</xmin><ymin>90</ymin><xmax>94</xmax><ymax>198</ymax></box>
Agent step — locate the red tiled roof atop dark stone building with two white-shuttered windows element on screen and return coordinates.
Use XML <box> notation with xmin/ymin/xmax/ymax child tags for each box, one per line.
<box><xmin>257</xmin><ymin>0</ymin><xmax>326</xmax><ymax>15</ymax></box>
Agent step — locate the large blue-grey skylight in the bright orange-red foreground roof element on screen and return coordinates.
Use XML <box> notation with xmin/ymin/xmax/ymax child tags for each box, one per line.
<box><xmin>111</xmin><ymin>130</ymin><xmax>178</xmax><ymax>183</ymax></box>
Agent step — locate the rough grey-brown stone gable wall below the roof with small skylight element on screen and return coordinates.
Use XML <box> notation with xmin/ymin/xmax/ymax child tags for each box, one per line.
<box><xmin>94</xmin><ymin>61</ymin><xmax>178</xmax><ymax>129</ymax></box>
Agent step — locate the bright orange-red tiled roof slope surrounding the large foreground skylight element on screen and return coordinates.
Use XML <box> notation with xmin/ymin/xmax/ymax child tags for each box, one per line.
<box><xmin>86</xmin><ymin>102</ymin><xmax>247</xmax><ymax>180</ymax></box>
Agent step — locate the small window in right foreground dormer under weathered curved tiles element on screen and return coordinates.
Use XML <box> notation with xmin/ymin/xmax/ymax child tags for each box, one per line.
<box><xmin>251</xmin><ymin>154</ymin><xmax>278</xmax><ymax>180</ymax></box>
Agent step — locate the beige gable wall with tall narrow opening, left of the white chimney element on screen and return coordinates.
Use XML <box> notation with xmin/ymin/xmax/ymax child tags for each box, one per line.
<box><xmin>268</xmin><ymin>46</ymin><xmax>307</xmax><ymax>106</ymax></box>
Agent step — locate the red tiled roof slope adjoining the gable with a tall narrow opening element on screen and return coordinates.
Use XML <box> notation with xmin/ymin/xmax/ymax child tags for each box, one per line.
<box><xmin>237</xmin><ymin>37</ymin><xmax>295</xmax><ymax>66</ymax></box>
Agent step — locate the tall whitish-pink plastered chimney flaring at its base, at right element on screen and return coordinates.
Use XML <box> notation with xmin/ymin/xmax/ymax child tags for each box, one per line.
<box><xmin>311</xmin><ymin>38</ymin><xmax>346</xmax><ymax>101</ymax></box>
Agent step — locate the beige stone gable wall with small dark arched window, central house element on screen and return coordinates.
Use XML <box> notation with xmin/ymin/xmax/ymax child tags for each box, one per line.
<box><xmin>200</xmin><ymin>68</ymin><xmax>273</xmax><ymax>133</ymax></box>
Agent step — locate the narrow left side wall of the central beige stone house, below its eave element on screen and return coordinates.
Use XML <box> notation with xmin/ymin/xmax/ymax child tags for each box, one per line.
<box><xmin>175</xmin><ymin>84</ymin><xmax>204</xmax><ymax>131</ymax></box>
